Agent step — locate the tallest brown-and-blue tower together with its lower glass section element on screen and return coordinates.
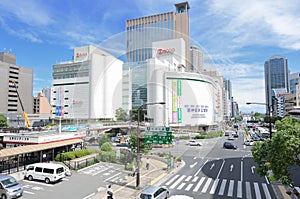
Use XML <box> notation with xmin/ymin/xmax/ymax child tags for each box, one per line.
<box><xmin>123</xmin><ymin>2</ymin><xmax>190</xmax><ymax>111</ymax></box>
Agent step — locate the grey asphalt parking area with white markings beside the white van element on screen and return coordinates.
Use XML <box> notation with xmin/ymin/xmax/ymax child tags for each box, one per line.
<box><xmin>21</xmin><ymin>163</ymin><xmax>127</xmax><ymax>199</ymax></box>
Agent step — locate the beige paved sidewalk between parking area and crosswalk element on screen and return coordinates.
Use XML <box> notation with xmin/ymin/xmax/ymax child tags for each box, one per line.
<box><xmin>85</xmin><ymin>158</ymin><xmax>181</xmax><ymax>199</ymax></box>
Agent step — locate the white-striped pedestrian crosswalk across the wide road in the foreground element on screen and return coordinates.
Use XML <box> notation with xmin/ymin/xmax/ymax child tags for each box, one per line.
<box><xmin>165</xmin><ymin>174</ymin><xmax>272</xmax><ymax>199</ymax></box>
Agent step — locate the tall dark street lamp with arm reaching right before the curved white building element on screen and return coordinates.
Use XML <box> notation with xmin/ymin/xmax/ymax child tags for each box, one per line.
<box><xmin>136</xmin><ymin>102</ymin><xmax>166</xmax><ymax>189</ymax></box>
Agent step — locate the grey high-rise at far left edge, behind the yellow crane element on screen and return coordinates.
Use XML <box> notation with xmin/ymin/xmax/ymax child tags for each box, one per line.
<box><xmin>0</xmin><ymin>52</ymin><xmax>33</xmax><ymax>114</ymax></box>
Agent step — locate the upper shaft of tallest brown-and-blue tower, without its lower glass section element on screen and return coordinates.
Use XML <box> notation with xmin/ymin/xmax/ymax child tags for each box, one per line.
<box><xmin>126</xmin><ymin>2</ymin><xmax>190</xmax><ymax>66</ymax></box>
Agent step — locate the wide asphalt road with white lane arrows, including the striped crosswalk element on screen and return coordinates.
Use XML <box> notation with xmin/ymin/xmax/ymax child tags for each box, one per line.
<box><xmin>159</xmin><ymin>132</ymin><xmax>276</xmax><ymax>199</ymax></box>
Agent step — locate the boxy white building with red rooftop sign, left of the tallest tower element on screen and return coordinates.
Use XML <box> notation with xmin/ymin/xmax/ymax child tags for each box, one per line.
<box><xmin>51</xmin><ymin>46</ymin><xmax>123</xmax><ymax>119</ymax></box>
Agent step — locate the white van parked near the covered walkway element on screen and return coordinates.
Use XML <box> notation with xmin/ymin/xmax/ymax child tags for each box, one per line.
<box><xmin>24</xmin><ymin>163</ymin><xmax>65</xmax><ymax>184</ymax></box>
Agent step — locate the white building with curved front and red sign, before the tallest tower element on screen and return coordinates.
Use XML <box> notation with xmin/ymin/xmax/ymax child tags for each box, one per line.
<box><xmin>147</xmin><ymin>39</ymin><xmax>219</xmax><ymax>130</ymax></box>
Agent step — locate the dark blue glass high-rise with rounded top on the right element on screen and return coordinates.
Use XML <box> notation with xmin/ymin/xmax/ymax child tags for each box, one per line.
<box><xmin>264</xmin><ymin>55</ymin><xmax>290</xmax><ymax>114</ymax></box>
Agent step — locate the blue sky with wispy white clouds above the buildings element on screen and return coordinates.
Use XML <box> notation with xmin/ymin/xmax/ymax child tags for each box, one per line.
<box><xmin>0</xmin><ymin>0</ymin><xmax>300</xmax><ymax>113</ymax></box>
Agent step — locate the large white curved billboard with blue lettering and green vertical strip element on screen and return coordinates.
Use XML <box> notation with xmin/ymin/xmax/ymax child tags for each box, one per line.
<box><xmin>167</xmin><ymin>74</ymin><xmax>214</xmax><ymax>126</ymax></box>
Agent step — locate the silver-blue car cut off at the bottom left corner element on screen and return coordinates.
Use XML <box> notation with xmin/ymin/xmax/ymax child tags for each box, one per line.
<box><xmin>0</xmin><ymin>175</ymin><xmax>23</xmax><ymax>198</ymax></box>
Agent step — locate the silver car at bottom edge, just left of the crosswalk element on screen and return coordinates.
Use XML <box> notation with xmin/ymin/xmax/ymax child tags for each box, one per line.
<box><xmin>139</xmin><ymin>186</ymin><xmax>169</xmax><ymax>199</ymax></box>
